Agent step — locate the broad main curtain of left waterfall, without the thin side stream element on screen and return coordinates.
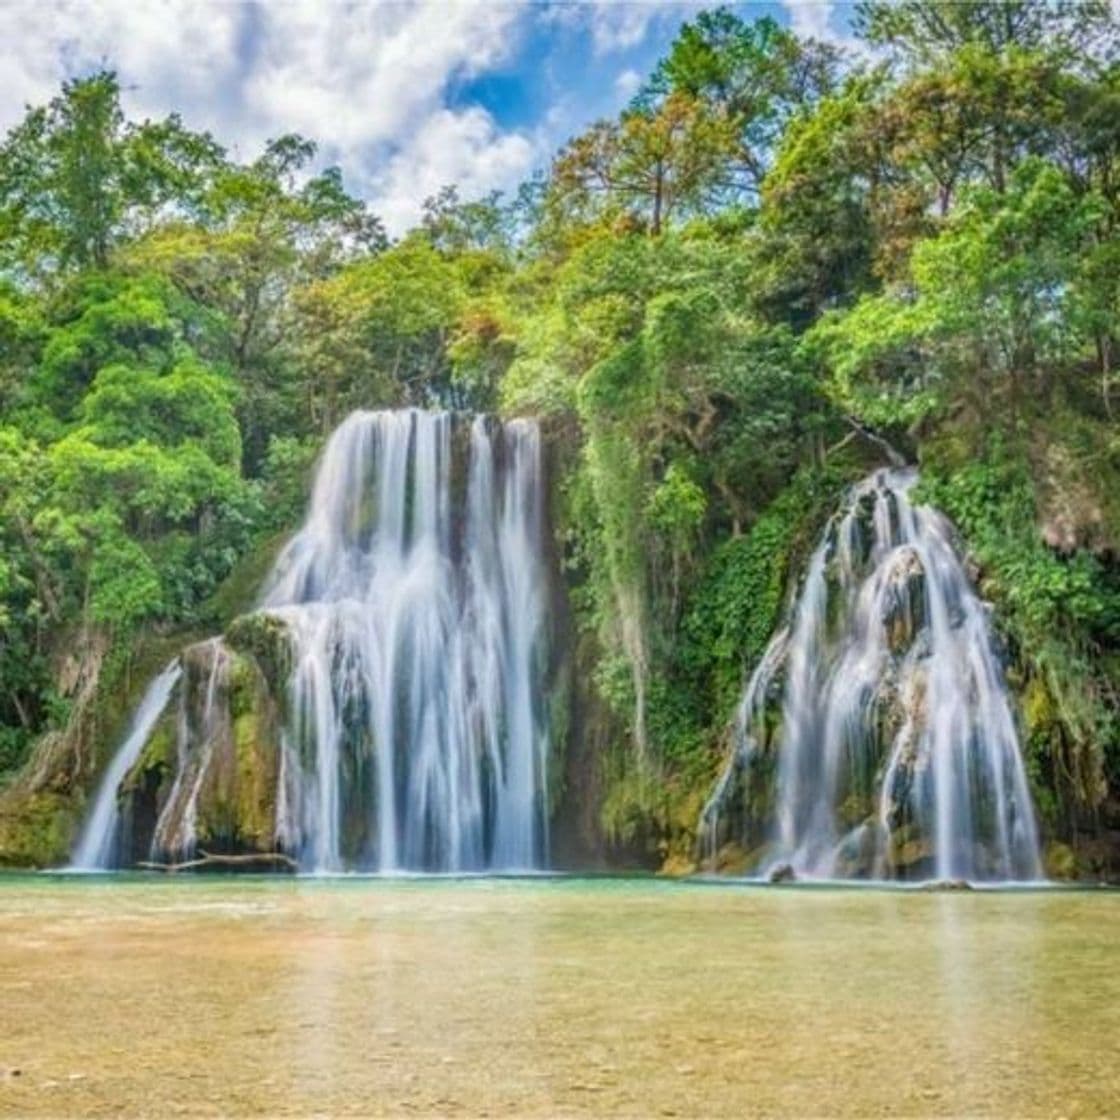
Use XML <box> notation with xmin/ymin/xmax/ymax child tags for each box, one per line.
<box><xmin>262</xmin><ymin>410</ymin><xmax>548</xmax><ymax>871</ymax></box>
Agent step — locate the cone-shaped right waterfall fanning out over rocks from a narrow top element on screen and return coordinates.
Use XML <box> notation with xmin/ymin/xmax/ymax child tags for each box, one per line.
<box><xmin>700</xmin><ymin>469</ymin><xmax>1042</xmax><ymax>880</ymax></box>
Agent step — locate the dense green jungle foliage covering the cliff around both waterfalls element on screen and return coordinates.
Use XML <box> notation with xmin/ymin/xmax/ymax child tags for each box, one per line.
<box><xmin>0</xmin><ymin>0</ymin><xmax>1120</xmax><ymax>861</ymax></box>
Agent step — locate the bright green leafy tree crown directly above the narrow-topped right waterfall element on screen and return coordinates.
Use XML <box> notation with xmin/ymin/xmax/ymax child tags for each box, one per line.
<box><xmin>808</xmin><ymin>160</ymin><xmax>1095</xmax><ymax>424</ymax></box>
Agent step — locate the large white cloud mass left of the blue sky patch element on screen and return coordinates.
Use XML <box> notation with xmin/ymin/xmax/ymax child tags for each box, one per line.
<box><xmin>0</xmin><ymin>0</ymin><xmax>536</xmax><ymax>233</ymax></box>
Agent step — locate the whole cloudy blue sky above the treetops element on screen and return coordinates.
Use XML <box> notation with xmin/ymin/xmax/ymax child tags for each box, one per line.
<box><xmin>0</xmin><ymin>0</ymin><xmax>850</xmax><ymax>234</ymax></box>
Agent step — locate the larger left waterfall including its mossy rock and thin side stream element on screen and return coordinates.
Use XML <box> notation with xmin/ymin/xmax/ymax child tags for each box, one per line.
<box><xmin>67</xmin><ymin>410</ymin><xmax>550</xmax><ymax>871</ymax></box>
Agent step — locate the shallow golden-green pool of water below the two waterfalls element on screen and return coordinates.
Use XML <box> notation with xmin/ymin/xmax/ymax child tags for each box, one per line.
<box><xmin>0</xmin><ymin>876</ymin><xmax>1120</xmax><ymax>1117</ymax></box>
